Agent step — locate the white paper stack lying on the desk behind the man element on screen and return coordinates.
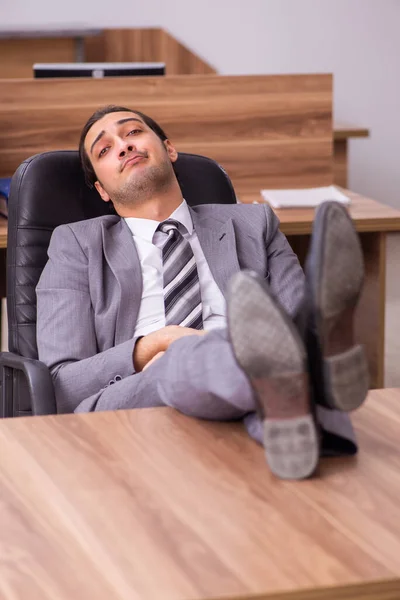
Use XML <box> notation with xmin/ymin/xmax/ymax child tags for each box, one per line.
<box><xmin>261</xmin><ymin>185</ymin><xmax>350</xmax><ymax>208</ymax></box>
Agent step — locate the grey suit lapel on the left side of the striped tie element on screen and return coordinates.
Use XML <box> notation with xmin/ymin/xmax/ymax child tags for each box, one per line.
<box><xmin>103</xmin><ymin>219</ymin><xmax>143</xmax><ymax>344</ymax></box>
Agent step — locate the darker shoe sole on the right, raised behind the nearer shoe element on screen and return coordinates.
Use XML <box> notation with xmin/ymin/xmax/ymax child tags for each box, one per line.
<box><xmin>305</xmin><ymin>202</ymin><xmax>369</xmax><ymax>412</ymax></box>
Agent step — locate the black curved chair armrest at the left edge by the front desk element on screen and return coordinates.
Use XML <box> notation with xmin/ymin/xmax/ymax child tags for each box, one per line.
<box><xmin>0</xmin><ymin>352</ymin><xmax>57</xmax><ymax>416</ymax></box>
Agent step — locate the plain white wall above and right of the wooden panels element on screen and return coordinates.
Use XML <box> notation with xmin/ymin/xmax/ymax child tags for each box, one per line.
<box><xmin>0</xmin><ymin>0</ymin><xmax>400</xmax><ymax>208</ymax></box>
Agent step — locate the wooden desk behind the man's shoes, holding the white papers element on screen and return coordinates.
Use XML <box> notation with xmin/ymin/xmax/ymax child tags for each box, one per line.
<box><xmin>240</xmin><ymin>189</ymin><xmax>400</xmax><ymax>388</ymax></box>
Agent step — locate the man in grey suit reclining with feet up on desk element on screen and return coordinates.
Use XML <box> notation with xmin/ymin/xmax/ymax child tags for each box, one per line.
<box><xmin>37</xmin><ymin>106</ymin><xmax>368</xmax><ymax>479</ymax></box>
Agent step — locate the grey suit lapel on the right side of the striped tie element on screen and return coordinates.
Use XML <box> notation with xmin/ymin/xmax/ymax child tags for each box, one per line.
<box><xmin>190</xmin><ymin>210</ymin><xmax>240</xmax><ymax>296</ymax></box>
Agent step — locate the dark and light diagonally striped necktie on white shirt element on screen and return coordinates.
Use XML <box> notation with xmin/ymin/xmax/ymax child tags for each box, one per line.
<box><xmin>157</xmin><ymin>219</ymin><xmax>203</xmax><ymax>329</ymax></box>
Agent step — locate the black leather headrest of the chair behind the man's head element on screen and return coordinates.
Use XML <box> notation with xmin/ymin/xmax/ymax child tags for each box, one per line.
<box><xmin>9</xmin><ymin>150</ymin><xmax>236</xmax><ymax>229</ymax></box>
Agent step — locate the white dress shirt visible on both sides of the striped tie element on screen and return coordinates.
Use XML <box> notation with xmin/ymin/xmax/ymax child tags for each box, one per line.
<box><xmin>125</xmin><ymin>200</ymin><xmax>226</xmax><ymax>336</ymax></box>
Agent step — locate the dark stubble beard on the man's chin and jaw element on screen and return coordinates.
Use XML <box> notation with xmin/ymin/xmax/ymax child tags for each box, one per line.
<box><xmin>112</xmin><ymin>160</ymin><xmax>175</xmax><ymax>207</ymax></box>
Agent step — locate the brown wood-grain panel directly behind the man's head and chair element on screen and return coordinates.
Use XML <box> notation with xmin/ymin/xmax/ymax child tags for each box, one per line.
<box><xmin>0</xmin><ymin>75</ymin><xmax>332</xmax><ymax>193</ymax></box>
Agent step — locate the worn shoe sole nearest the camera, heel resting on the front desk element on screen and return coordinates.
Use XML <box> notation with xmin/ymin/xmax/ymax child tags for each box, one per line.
<box><xmin>228</xmin><ymin>272</ymin><xmax>319</xmax><ymax>479</ymax></box>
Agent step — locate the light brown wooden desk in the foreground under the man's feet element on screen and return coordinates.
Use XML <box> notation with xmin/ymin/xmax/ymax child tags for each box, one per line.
<box><xmin>0</xmin><ymin>390</ymin><xmax>400</xmax><ymax>600</ymax></box>
